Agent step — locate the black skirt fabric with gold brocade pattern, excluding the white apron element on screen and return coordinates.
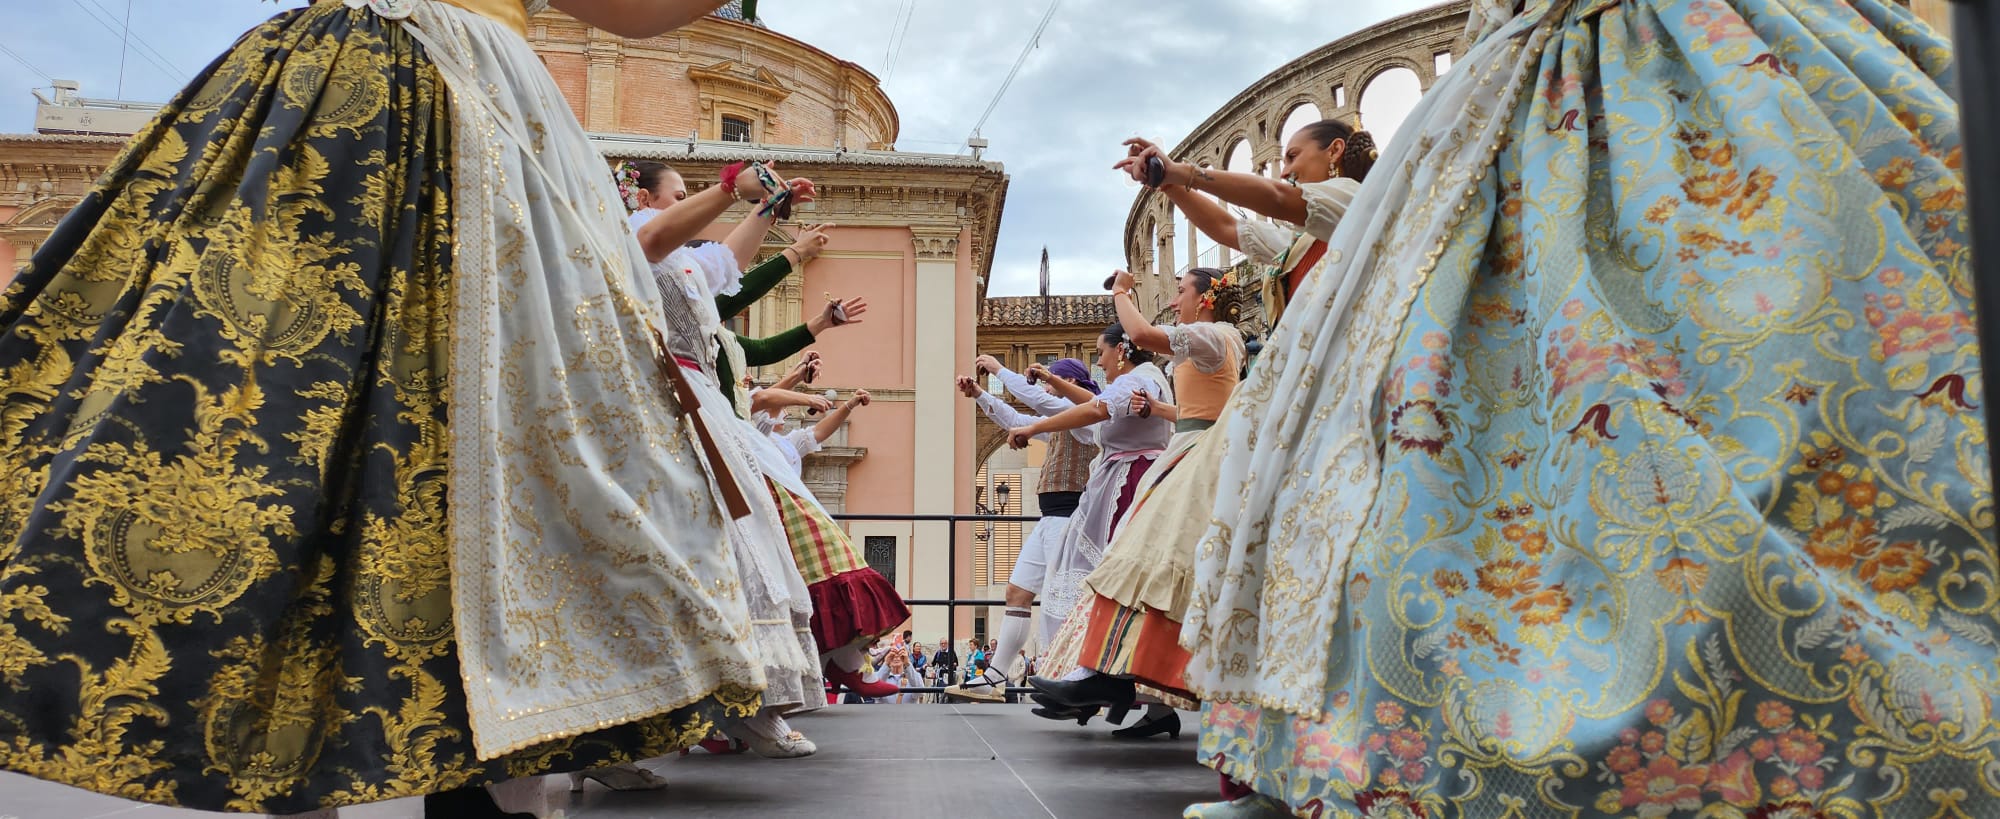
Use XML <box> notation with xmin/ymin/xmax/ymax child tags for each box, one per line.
<box><xmin>0</xmin><ymin>4</ymin><xmax>756</xmax><ymax>813</ymax></box>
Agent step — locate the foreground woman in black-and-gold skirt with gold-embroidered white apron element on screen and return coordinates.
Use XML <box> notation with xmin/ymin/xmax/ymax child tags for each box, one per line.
<box><xmin>0</xmin><ymin>0</ymin><xmax>780</xmax><ymax>817</ymax></box>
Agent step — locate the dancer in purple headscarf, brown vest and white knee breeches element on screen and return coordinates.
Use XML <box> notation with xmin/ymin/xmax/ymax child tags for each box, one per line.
<box><xmin>946</xmin><ymin>356</ymin><xmax>1100</xmax><ymax>703</ymax></box>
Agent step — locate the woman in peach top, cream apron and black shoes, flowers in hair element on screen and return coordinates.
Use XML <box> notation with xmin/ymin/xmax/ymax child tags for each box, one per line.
<box><xmin>1030</xmin><ymin>268</ymin><xmax>1246</xmax><ymax>737</ymax></box>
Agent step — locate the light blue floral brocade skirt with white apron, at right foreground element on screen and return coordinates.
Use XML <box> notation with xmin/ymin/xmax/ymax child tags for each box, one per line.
<box><xmin>1184</xmin><ymin>0</ymin><xmax>2000</xmax><ymax>819</ymax></box>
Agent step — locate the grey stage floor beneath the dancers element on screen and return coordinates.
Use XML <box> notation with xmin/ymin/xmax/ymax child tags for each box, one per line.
<box><xmin>0</xmin><ymin>705</ymin><xmax>1216</xmax><ymax>819</ymax></box>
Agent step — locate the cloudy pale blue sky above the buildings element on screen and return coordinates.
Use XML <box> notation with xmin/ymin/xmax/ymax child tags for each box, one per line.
<box><xmin>0</xmin><ymin>0</ymin><xmax>1432</xmax><ymax>296</ymax></box>
